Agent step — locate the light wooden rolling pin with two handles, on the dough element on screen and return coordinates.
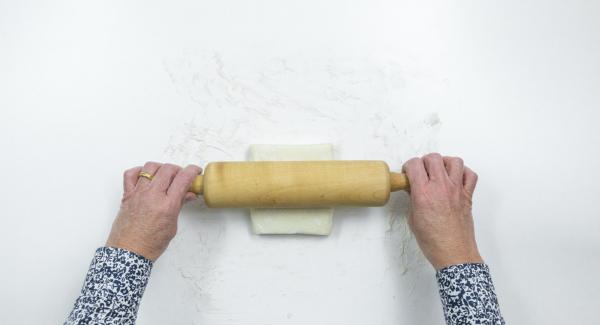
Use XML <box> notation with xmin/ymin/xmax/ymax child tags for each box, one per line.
<box><xmin>190</xmin><ymin>160</ymin><xmax>409</xmax><ymax>208</ymax></box>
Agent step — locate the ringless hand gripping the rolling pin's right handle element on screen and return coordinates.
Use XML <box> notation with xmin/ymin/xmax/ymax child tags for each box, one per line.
<box><xmin>403</xmin><ymin>153</ymin><xmax>483</xmax><ymax>270</ymax></box>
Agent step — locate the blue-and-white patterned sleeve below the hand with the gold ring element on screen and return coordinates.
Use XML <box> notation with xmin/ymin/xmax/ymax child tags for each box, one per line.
<box><xmin>65</xmin><ymin>247</ymin><xmax>152</xmax><ymax>325</ymax></box>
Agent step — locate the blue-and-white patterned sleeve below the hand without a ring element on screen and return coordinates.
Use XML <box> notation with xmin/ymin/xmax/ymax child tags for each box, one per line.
<box><xmin>437</xmin><ymin>264</ymin><xmax>505</xmax><ymax>325</ymax></box>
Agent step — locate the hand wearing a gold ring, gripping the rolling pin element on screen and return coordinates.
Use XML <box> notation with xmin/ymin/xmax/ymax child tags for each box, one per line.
<box><xmin>106</xmin><ymin>162</ymin><xmax>202</xmax><ymax>261</ymax></box>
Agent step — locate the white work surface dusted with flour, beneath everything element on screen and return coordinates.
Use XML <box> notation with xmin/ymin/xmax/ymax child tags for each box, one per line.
<box><xmin>0</xmin><ymin>0</ymin><xmax>600</xmax><ymax>325</ymax></box>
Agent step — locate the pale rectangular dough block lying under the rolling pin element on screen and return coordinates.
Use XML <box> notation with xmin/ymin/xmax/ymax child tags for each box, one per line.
<box><xmin>250</xmin><ymin>144</ymin><xmax>333</xmax><ymax>235</ymax></box>
